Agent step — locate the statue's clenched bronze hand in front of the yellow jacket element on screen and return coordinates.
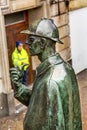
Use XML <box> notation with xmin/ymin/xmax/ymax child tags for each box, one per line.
<box><xmin>10</xmin><ymin>67</ymin><xmax>23</xmax><ymax>83</ymax></box>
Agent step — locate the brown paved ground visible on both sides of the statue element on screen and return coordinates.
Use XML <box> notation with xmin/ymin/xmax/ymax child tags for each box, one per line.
<box><xmin>0</xmin><ymin>70</ymin><xmax>87</xmax><ymax>130</ymax></box>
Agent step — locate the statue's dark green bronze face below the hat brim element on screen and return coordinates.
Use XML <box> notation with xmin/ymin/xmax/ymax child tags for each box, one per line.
<box><xmin>28</xmin><ymin>36</ymin><xmax>42</xmax><ymax>56</ymax></box>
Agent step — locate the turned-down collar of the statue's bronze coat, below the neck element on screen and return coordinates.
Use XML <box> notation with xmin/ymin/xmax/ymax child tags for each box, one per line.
<box><xmin>36</xmin><ymin>53</ymin><xmax>63</xmax><ymax>76</ymax></box>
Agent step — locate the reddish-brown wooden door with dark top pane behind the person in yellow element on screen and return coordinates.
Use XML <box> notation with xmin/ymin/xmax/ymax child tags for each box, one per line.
<box><xmin>5</xmin><ymin>11</ymin><xmax>33</xmax><ymax>84</ymax></box>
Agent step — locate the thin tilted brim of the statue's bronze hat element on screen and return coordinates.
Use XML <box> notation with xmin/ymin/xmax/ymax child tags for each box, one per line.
<box><xmin>20</xmin><ymin>30</ymin><xmax>63</xmax><ymax>44</ymax></box>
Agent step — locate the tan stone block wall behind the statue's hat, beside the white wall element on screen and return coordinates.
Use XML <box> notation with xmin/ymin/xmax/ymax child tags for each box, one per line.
<box><xmin>50</xmin><ymin>0</ymin><xmax>71</xmax><ymax>61</ymax></box>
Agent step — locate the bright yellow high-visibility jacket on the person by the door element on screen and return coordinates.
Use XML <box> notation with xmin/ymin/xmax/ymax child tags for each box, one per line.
<box><xmin>12</xmin><ymin>48</ymin><xmax>30</xmax><ymax>70</ymax></box>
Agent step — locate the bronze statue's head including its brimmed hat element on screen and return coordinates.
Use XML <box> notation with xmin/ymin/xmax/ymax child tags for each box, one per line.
<box><xmin>21</xmin><ymin>18</ymin><xmax>62</xmax><ymax>55</ymax></box>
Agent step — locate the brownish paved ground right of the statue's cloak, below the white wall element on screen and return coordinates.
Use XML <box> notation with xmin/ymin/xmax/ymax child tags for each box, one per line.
<box><xmin>77</xmin><ymin>70</ymin><xmax>87</xmax><ymax>130</ymax></box>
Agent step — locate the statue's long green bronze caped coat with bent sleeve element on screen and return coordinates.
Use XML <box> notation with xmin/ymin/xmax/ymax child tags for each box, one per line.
<box><xmin>15</xmin><ymin>54</ymin><xmax>82</xmax><ymax>130</ymax></box>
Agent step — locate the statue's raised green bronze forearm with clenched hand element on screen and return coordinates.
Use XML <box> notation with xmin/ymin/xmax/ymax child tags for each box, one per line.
<box><xmin>10</xmin><ymin>68</ymin><xmax>32</xmax><ymax>106</ymax></box>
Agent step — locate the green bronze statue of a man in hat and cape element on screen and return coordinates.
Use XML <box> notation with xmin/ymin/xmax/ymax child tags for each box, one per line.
<box><xmin>11</xmin><ymin>18</ymin><xmax>82</xmax><ymax>130</ymax></box>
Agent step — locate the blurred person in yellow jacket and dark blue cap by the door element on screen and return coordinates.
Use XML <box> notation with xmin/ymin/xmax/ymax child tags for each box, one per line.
<box><xmin>12</xmin><ymin>41</ymin><xmax>30</xmax><ymax>85</ymax></box>
